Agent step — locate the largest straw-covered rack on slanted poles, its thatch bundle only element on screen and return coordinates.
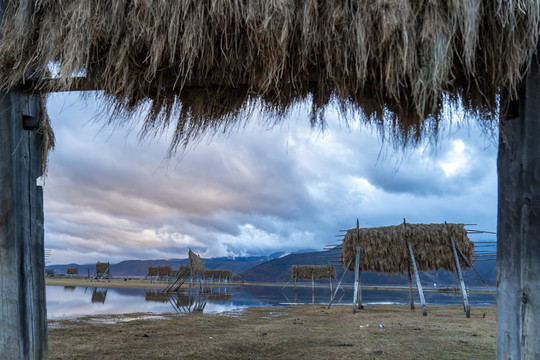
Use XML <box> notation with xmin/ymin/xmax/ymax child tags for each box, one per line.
<box><xmin>341</xmin><ymin>224</ymin><xmax>474</xmax><ymax>274</ymax></box>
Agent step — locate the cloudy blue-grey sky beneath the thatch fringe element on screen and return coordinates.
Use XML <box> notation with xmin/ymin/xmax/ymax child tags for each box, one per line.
<box><xmin>44</xmin><ymin>94</ymin><xmax>497</xmax><ymax>264</ymax></box>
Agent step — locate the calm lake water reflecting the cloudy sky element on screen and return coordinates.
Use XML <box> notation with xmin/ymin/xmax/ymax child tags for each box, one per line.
<box><xmin>46</xmin><ymin>285</ymin><xmax>495</xmax><ymax>319</ymax></box>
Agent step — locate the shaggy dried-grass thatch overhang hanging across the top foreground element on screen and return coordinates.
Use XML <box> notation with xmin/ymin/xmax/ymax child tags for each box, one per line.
<box><xmin>0</xmin><ymin>0</ymin><xmax>540</xmax><ymax>159</ymax></box>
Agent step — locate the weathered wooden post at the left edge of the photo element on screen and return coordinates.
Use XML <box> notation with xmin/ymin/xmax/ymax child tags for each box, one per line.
<box><xmin>0</xmin><ymin>90</ymin><xmax>47</xmax><ymax>359</ymax></box>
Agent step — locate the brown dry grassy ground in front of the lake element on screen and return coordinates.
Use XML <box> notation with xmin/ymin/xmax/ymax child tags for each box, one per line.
<box><xmin>46</xmin><ymin>305</ymin><xmax>496</xmax><ymax>360</ymax></box>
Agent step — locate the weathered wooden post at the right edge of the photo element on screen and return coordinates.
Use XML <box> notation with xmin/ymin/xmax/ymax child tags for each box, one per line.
<box><xmin>497</xmin><ymin>52</ymin><xmax>540</xmax><ymax>359</ymax></box>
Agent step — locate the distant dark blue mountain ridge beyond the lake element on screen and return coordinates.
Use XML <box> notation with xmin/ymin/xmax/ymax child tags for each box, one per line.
<box><xmin>46</xmin><ymin>251</ymin><xmax>496</xmax><ymax>287</ymax></box>
